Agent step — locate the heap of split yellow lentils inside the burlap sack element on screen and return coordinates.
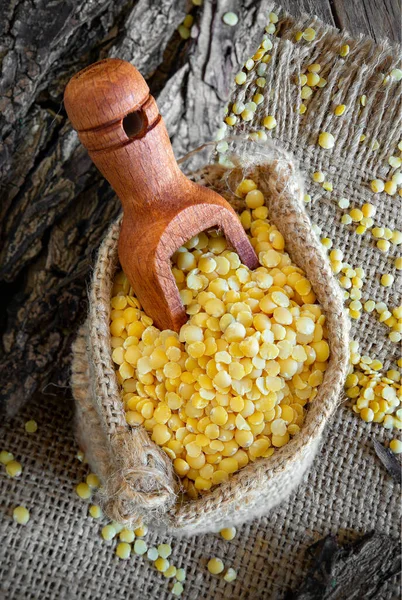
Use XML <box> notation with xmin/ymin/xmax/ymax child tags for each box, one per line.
<box><xmin>110</xmin><ymin>179</ymin><xmax>329</xmax><ymax>498</ymax></box>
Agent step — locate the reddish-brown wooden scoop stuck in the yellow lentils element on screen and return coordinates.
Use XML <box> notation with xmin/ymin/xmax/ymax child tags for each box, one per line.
<box><xmin>64</xmin><ymin>58</ymin><xmax>258</xmax><ymax>331</ymax></box>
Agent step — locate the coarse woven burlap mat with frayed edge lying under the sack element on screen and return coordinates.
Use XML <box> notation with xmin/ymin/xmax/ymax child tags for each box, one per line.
<box><xmin>0</xmin><ymin>5</ymin><xmax>401</xmax><ymax>600</ymax></box>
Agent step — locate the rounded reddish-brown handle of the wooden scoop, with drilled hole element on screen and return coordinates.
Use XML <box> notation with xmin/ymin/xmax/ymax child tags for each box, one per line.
<box><xmin>64</xmin><ymin>58</ymin><xmax>186</xmax><ymax>219</ymax></box>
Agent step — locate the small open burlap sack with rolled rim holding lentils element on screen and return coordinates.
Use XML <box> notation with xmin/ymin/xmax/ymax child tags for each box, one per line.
<box><xmin>71</xmin><ymin>142</ymin><xmax>349</xmax><ymax>534</ymax></box>
